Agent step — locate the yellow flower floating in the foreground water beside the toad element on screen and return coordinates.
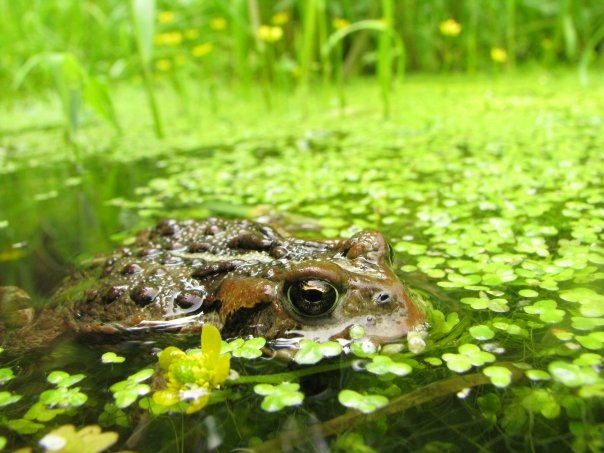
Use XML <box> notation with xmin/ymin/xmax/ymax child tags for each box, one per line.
<box><xmin>153</xmin><ymin>325</ymin><xmax>231</xmax><ymax>414</ymax></box>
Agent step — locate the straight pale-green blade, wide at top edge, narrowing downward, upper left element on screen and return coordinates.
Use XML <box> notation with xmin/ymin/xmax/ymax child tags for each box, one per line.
<box><xmin>130</xmin><ymin>0</ymin><xmax>164</xmax><ymax>138</ymax></box>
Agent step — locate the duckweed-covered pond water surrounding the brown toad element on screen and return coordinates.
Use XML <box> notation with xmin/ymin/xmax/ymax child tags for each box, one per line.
<box><xmin>0</xmin><ymin>73</ymin><xmax>604</xmax><ymax>452</ymax></box>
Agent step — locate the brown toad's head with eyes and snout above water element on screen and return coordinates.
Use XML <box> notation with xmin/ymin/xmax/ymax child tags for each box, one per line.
<box><xmin>219</xmin><ymin>231</ymin><xmax>425</xmax><ymax>343</ymax></box>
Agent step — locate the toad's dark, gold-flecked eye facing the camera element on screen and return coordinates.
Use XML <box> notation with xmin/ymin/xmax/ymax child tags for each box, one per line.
<box><xmin>286</xmin><ymin>279</ymin><xmax>338</xmax><ymax>317</ymax></box>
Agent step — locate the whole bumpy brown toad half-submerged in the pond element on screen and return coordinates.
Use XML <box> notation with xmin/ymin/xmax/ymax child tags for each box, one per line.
<box><xmin>0</xmin><ymin>218</ymin><xmax>425</xmax><ymax>351</ymax></box>
